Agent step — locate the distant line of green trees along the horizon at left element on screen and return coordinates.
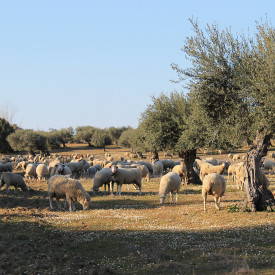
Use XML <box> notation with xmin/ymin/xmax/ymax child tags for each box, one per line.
<box><xmin>0</xmin><ymin>121</ymin><xmax>132</xmax><ymax>154</ymax></box>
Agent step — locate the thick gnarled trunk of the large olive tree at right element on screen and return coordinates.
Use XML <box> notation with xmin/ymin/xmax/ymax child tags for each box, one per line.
<box><xmin>240</xmin><ymin>130</ymin><xmax>275</xmax><ymax>212</ymax></box>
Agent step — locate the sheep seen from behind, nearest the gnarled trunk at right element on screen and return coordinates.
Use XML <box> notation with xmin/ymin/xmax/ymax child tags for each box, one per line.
<box><xmin>202</xmin><ymin>173</ymin><xmax>226</xmax><ymax>211</ymax></box>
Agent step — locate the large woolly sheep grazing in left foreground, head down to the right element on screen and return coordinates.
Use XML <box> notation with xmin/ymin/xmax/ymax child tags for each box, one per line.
<box><xmin>48</xmin><ymin>175</ymin><xmax>91</xmax><ymax>212</ymax></box>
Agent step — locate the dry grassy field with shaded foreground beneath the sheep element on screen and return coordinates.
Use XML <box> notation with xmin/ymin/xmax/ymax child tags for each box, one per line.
<box><xmin>0</xmin><ymin>145</ymin><xmax>275</xmax><ymax>274</ymax></box>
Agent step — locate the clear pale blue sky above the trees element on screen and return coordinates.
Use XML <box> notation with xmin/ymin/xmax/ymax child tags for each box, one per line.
<box><xmin>0</xmin><ymin>0</ymin><xmax>275</xmax><ymax>131</ymax></box>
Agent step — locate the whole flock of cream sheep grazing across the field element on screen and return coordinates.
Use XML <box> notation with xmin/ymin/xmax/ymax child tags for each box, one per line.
<box><xmin>0</xmin><ymin>153</ymin><xmax>275</xmax><ymax>211</ymax></box>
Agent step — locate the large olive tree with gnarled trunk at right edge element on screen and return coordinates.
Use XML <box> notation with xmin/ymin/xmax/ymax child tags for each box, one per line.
<box><xmin>172</xmin><ymin>19</ymin><xmax>275</xmax><ymax>211</ymax></box>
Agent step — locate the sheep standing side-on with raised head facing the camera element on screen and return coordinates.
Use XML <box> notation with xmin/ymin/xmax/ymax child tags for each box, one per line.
<box><xmin>111</xmin><ymin>165</ymin><xmax>142</xmax><ymax>195</ymax></box>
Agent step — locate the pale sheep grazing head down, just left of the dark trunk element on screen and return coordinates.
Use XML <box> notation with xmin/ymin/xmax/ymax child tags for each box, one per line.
<box><xmin>159</xmin><ymin>172</ymin><xmax>181</xmax><ymax>204</ymax></box>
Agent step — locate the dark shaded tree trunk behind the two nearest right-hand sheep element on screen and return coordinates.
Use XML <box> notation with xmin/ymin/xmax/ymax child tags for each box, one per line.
<box><xmin>179</xmin><ymin>149</ymin><xmax>202</xmax><ymax>184</ymax></box>
